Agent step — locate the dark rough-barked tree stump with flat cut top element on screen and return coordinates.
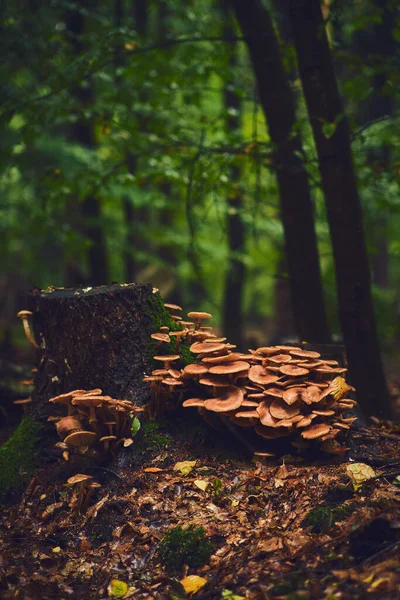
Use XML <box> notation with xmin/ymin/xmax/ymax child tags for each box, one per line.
<box><xmin>29</xmin><ymin>284</ymin><xmax>170</xmax><ymax>421</ymax></box>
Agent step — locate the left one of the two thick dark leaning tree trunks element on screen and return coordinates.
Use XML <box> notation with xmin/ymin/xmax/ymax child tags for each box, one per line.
<box><xmin>230</xmin><ymin>0</ymin><xmax>330</xmax><ymax>342</ymax></box>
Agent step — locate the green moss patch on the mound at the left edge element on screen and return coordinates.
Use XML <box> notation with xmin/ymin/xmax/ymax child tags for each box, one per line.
<box><xmin>0</xmin><ymin>417</ymin><xmax>40</xmax><ymax>498</ymax></box>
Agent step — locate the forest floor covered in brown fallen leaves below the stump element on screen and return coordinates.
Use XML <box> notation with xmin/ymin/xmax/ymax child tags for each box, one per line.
<box><xmin>0</xmin><ymin>406</ymin><xmax>400</xmax><ymax>600</ymax></box>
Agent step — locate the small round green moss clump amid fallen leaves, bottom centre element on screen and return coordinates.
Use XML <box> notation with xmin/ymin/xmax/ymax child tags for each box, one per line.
<box><xmin>159</xmin><ymin>525</ymin><xmax>213</xmax><ymax>573</ymax></box>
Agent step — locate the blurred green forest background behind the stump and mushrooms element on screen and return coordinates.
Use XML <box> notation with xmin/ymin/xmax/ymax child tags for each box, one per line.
<box><xmin>0</xmin><ymin>0</ymin><xmax>400</xmax><ymax>408</ymax></box>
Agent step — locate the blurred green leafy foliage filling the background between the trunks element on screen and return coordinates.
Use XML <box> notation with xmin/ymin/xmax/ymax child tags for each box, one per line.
<box><xmin>0</xmin><ymin>0</ymin><xmax>400</xmax><ymax>346</ymax></box>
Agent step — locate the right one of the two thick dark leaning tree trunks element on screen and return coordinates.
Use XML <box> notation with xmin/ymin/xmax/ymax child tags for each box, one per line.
<box><xmin>289</xmin><ymin>0</ymin><xmax>390</xmax><ymax>417</ymax></box>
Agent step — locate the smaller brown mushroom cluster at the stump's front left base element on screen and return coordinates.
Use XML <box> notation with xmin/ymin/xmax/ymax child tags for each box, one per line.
<box><xmin>48</xmin><ymin>388</ymin><xmax>141</xmax><ymax>454</ymax></box>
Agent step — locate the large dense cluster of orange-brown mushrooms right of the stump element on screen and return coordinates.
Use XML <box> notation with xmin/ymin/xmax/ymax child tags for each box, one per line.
<box><xmin>145</xmin><ymin>305</ymin><xmax>356</xmax><ymax>454</ymax></box>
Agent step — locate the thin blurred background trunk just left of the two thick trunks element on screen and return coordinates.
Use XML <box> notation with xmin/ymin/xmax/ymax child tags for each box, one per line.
<box><xmin>222</xmin><ymin>0</ymin><xmax>246</xmax><ymax>348</ymax></box>
